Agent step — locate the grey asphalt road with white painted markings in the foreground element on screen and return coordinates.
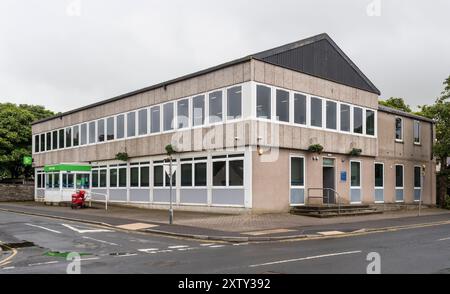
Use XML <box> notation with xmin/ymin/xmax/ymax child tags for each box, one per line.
<box><xmin>0</xmin><ymin>212</ymin><xmax>450</xmax><ymax>274</ymax></box>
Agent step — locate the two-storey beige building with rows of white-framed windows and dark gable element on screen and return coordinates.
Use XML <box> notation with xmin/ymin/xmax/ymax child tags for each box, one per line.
<box><xmin>32</xmin><ymin>34</ymin><xmax>436</xmax><ymax>213</ymax></box>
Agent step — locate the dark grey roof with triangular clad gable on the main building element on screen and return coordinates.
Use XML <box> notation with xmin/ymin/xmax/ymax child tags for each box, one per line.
<box><xmin>32</xmin><ymin>33</ymin><xmax>380</xmax><ymax>125</ymax></box>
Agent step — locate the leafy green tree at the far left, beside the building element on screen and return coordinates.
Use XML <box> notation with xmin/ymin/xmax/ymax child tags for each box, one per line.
<box><xmin>0</xmin><ymin>103</ymin><xmax>54</xmax><ymax>178</ymax></box>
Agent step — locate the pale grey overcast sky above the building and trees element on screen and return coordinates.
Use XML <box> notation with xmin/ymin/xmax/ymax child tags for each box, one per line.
<box><xmin>0</xmin><ymin>0</ymin><xmax>450</xmax><ymax>111</ymax></box>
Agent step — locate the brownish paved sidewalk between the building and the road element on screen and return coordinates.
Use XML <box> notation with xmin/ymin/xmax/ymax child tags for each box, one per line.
<box><xmin>0</xmin><ymin>202</ymin><xmax>450</xmax><ymax>242</ymax></box>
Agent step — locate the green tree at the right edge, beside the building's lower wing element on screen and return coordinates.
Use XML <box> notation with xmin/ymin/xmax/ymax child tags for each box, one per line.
<box><xmin>419</xmin><ymin>76</ymin><xmax>450</xmax><ymax>206</ymax></box>
